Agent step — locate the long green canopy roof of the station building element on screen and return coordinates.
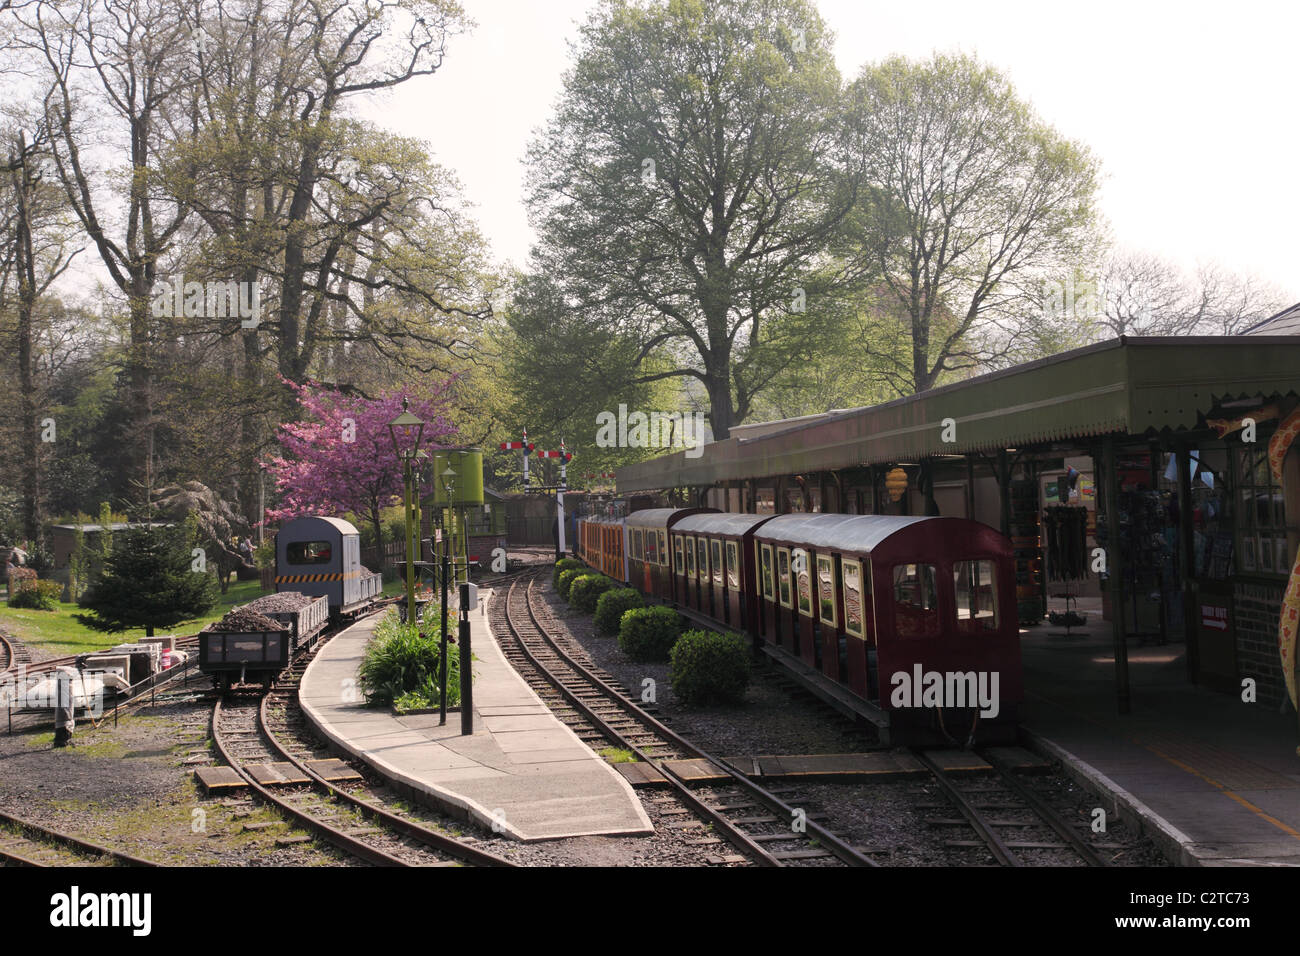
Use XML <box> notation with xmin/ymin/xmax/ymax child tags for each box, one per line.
<box><xmin>616</xmin><ymin>336</ymin><xmax>1300</xmax><ymax>493</ymax></box>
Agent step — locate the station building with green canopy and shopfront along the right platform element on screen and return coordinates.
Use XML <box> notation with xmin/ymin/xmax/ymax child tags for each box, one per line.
<box><xmin>618</xmin><ymin>332</ymin><xmax>1300</xmax><ymax>713</ymax></box>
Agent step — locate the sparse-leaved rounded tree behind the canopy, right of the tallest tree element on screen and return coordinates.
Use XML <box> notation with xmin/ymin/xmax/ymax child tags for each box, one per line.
<box><xmin>837</xmin><ymin>55</ymin><xmax>1099</xmax><ymax>392</ymax></box>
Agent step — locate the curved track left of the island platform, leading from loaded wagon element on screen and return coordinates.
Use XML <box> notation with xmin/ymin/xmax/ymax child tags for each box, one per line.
<box><xmin>212</xmin><ymin>616</ymin><xmax>514</xmax><ymax>866</ymax></box>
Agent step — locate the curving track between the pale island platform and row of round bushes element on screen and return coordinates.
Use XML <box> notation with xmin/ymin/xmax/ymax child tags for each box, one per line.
<box><xmin>493</xmin><ymin>570</ymin><xmax>876</xmax><ymax>866</ymax></box>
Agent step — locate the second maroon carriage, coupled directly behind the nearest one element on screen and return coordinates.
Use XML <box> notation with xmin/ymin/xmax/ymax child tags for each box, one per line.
<box><xmin>672</xmin><ymin>512</ymin><xmax>772</xmax><ymax>637</ymax></box>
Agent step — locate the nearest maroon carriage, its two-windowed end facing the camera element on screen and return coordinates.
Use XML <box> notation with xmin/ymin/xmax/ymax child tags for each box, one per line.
<box><xmin>754</xmin><ymin>514</ymin><xmax>1023</xmax><ymax>739</ymax></box>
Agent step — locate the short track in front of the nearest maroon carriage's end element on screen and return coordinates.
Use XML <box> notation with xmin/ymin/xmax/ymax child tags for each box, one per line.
<box><xmin>913</xmin><ymin>750</ymin><xmax>1108</xmax><ymax>866</ymax></box>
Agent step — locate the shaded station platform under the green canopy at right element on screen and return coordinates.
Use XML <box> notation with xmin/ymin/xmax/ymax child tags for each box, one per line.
<box><xmin>1021</xmin><ymin>601</ymin><xmax>1300</xmax><ymax>866</ymax></box>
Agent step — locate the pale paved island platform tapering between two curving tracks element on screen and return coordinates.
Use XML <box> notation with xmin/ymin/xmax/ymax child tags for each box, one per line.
<box><xmin>299</xmin><ymin>589</ymin><xmax>653</xmax><ymax>840</ymax></box>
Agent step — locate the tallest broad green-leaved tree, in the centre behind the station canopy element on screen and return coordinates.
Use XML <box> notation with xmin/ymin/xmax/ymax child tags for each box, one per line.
<box><xmin>529</xmin><ymin>0</ymin><xmax>858</xmax><ymax>438</ymax></box>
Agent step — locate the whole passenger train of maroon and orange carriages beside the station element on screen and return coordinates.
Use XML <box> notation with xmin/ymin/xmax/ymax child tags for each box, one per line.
<box><xmin>577</xmin><ymin>509</ymin><xmax>1023</xmax><ymax>744</ymax></box>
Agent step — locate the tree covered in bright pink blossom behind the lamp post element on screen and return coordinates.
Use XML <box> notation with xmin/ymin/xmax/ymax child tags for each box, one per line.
<box><xmin>263</xmin><ymin>378</ymin><xmax>456</xmax><ymax>541</ymax></box>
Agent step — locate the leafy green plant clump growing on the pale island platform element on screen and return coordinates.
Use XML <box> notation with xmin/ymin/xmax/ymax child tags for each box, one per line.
<box><xmin>359</xmin><ymin>614</ymin><xmax>460</xmax><ymax>709</ymax></box>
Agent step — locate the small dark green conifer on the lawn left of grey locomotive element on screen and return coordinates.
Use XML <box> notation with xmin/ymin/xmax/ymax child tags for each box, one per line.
<box><xmin>77</xmin><ymin>522</ymin><xmax>217</xmax><ymax>637</ymax></box>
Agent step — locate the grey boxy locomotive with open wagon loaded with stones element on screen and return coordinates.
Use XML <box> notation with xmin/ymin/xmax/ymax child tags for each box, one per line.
<box><xmin>199</xmin><ymin>516</ymin><xmax>384</xmax><ymax>689</ymax></box>
